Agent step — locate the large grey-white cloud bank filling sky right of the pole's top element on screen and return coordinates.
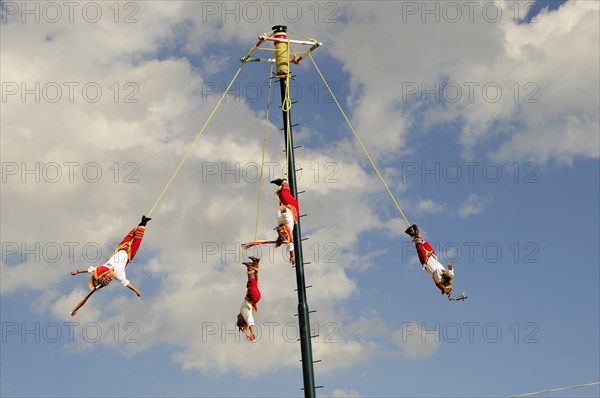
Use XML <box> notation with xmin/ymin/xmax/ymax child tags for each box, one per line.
<box><xmin>324</xmin><ymin>1</ymin><xmax>600</xmax><ymax>162</ymax></box>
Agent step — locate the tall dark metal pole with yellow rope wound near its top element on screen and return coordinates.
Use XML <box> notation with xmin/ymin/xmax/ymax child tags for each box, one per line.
<box><xmin>273</xmin><ymin>25</ymin><xmax>316</xmax><ymax>398</ymax></box>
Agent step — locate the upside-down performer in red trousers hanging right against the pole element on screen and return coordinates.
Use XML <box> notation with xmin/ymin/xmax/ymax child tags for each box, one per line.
<box><xmin>271</xmin><ymin>178</ymin><xmax>300</xmax><ymax>264</ymax></box>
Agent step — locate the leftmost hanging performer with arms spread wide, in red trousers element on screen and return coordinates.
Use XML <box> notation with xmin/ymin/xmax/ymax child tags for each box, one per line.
<box><xmin>71</xmin><ymin>216</ymin><xmax>151</xmax><ymax>297</ymax></box>
